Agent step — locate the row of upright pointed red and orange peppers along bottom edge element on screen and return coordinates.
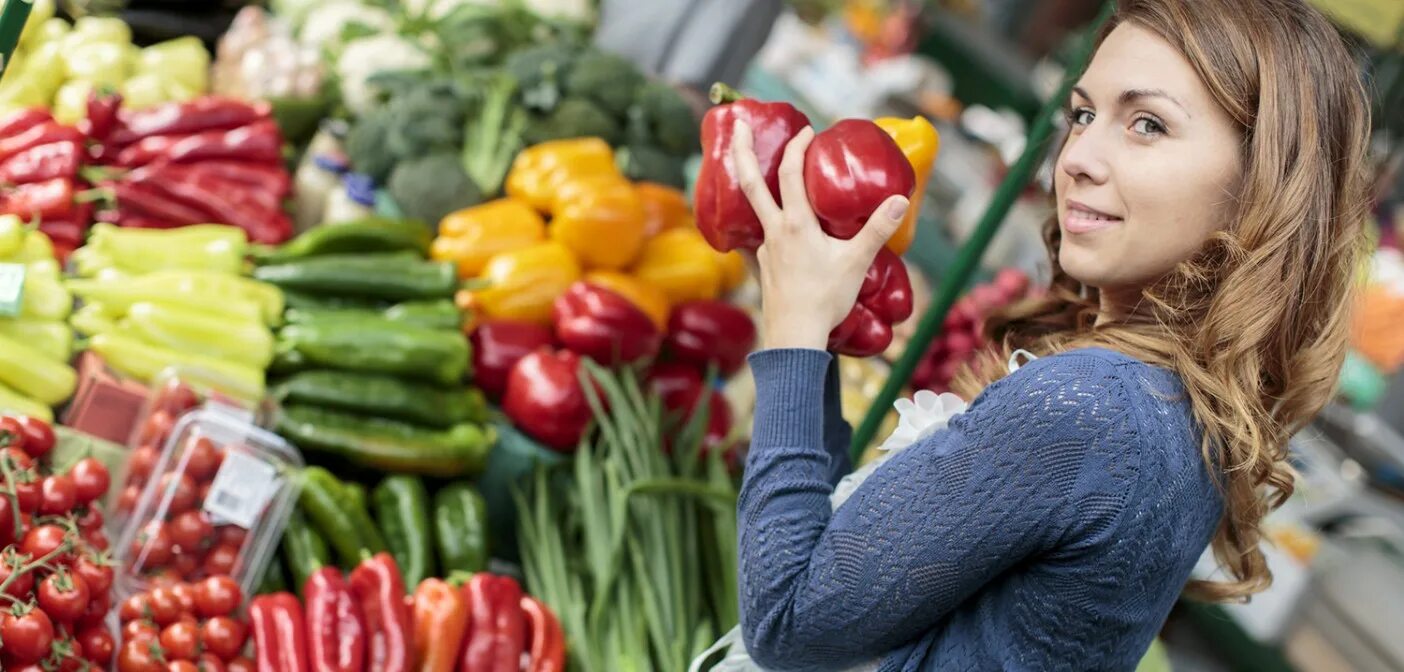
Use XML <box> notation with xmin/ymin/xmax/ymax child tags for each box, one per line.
<box><xmin>249</xmin><ymin>553</ymin><xmax>566</xmax><ymax>672</ymax></box>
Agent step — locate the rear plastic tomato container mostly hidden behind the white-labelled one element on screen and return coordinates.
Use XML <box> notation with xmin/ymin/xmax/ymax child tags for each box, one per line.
<box><xmin>107</xmin><ymin>366</ymin><xmax>267</xmax><ymax>535</ymax></box>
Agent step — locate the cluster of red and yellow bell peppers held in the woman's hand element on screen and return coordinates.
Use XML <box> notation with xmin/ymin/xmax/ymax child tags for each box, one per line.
<box><xmin>695</xmin><ymin>86</ymin><xmax>939</xmax><ymax>356</ymax></box>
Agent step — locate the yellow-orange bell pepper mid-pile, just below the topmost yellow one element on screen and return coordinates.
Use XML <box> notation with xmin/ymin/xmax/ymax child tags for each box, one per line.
<box><xmin>550</xmin><ymin>177</ymin><xmax>644</xmax><ymax>271</ymax></box>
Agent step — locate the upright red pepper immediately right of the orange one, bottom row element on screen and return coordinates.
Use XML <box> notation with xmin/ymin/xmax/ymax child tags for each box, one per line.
<box><xmin>459</xmin><ymin>572</ymin><xmax>527</xmax><ymax>672</ymax></box>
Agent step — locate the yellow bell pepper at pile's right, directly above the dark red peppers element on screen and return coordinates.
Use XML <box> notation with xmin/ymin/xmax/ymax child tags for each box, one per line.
<box><xmin>633</xmin><ymin>229</ymin><xmax>722</xmax><ymax>306</ymax></box>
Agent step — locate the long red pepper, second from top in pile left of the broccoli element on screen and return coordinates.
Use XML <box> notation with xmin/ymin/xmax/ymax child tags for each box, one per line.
<box><xmin>117</xmin><ymin>121</ymin><xmax>282</xmax><ymax>167</ymax></box>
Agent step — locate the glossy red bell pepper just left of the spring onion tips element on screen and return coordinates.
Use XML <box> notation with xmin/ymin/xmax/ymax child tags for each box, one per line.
<box><xmin>503</xmin><ymin>348</ymin><xmax>591</xmax><ymax>452</ymax></box>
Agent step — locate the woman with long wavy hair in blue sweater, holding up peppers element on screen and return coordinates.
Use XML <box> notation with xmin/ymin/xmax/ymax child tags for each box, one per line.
<box><xmin>733</xmin><ymin>0</ymin><xmax>1369</xmax><ymax>671</ymax></box>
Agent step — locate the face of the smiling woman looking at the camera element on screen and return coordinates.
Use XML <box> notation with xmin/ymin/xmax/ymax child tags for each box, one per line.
<box><xmin>1054</xmin><ymin>24</ymin><xmax>1241</xmax><ymax>296</ymax></box>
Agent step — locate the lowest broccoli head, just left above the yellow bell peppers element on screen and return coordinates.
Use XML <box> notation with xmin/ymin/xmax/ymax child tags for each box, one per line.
<box><xmin>388</xmin><ymin>152</ymin><xmax>483</xmax><ymax>227</ymax></box>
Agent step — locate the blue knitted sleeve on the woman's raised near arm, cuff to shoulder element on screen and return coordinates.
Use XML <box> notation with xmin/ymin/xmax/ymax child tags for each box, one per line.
<box><xmin>737</xmin><ymin>351</ymin><xmax>1136</xmax><ymax>671</ymax></box>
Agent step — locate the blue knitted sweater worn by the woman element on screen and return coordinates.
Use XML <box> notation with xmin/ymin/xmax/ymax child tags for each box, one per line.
<box><xmin>739</xmin><ymin>349</ymin><xmax>1223</xmax><ymax>672</ymax></box>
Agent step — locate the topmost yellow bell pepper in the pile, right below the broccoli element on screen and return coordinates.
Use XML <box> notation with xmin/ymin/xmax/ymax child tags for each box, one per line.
<box><xmin>504</xmin><ymin>137</ymin><xmax>619</xmax><ymax>212</ymax></box>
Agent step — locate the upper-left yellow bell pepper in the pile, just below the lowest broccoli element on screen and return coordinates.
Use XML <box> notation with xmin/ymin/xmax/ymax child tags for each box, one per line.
<box><xmin>430</xmin><ymin>198</ymin><xmax>546</xmax><ymax>279</ymax></box>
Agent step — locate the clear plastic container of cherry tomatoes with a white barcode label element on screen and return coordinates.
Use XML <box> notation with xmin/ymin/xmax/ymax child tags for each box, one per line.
<box><xmin>114</xmin><ymin>407</ymin><xmax>303</xmax><ymax>606</ymax></box>
